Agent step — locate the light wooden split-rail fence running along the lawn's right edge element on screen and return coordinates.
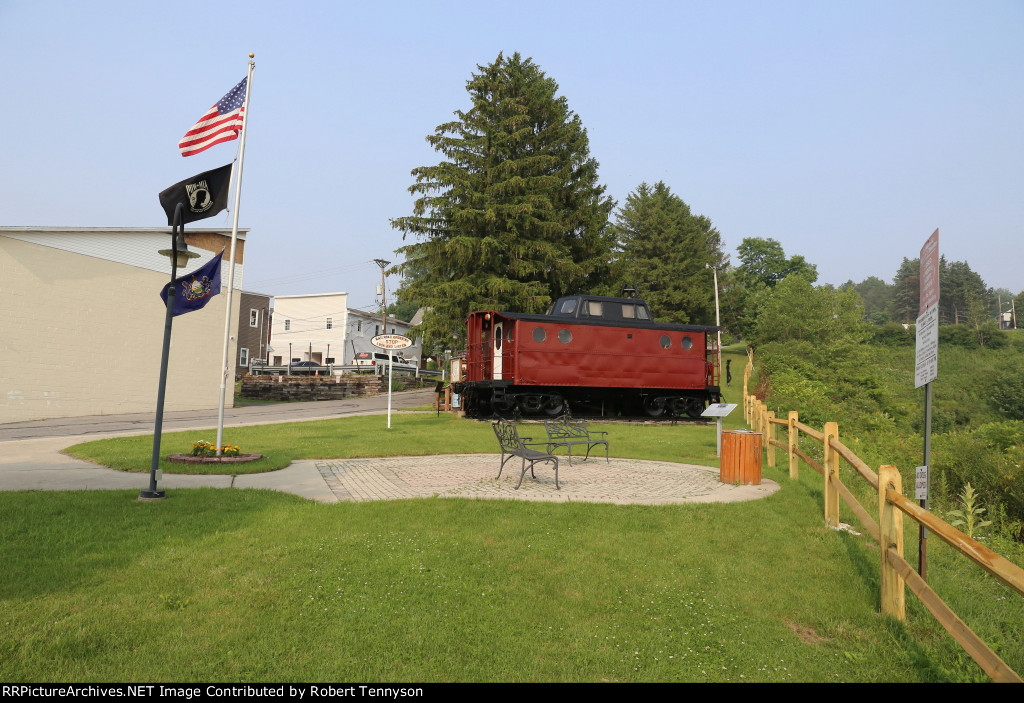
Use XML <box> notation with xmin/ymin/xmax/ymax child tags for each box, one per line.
<box><xmin>743</xmin><ymin>354</ymin><xmax>1024</xmax><ymax>684</ymax></box>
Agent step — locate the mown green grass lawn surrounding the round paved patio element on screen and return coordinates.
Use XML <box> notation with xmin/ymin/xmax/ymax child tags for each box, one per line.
<box><xmin>0</xmin><ymin>352</ymin><xmax>1024</xmax><ymax>683</ymax></box>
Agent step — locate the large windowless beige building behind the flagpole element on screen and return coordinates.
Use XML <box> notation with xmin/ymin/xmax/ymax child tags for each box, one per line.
<box><xmin>0</xmin><ymin>227</ymin><xmax>248</xmax><ymax>423</ymax></box>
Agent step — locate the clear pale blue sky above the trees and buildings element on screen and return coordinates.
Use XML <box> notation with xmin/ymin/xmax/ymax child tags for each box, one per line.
<box><xmin>0</xmin><ymin>0</ymin><xmax>1024</xmax><ymax>308</ymax></box>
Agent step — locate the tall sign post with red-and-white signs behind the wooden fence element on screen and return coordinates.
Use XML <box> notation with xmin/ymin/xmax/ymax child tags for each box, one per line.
<box><xmin>913</xmin><ymin>229</ymin><xmax>939</xmax><ymax>578</ymax></box>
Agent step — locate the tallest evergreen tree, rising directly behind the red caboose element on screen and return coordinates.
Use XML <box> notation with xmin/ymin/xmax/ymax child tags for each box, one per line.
<box><xmin>391</xmin><ymin>53</ymin><xmax>614</xmax><ymax>345</ymax></box>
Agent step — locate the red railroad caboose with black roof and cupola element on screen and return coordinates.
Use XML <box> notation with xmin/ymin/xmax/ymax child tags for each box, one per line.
<box><xmin>455</xmin><ymin>296</ymin><xmax>721</xmax><ymax>418</ymax></box>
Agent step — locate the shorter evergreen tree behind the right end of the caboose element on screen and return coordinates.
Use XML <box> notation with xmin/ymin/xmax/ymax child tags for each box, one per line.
<box><xmin>612</xmin><ymin>182</ymin><xmax>725</xmax><ymax>324</ymax></box>
